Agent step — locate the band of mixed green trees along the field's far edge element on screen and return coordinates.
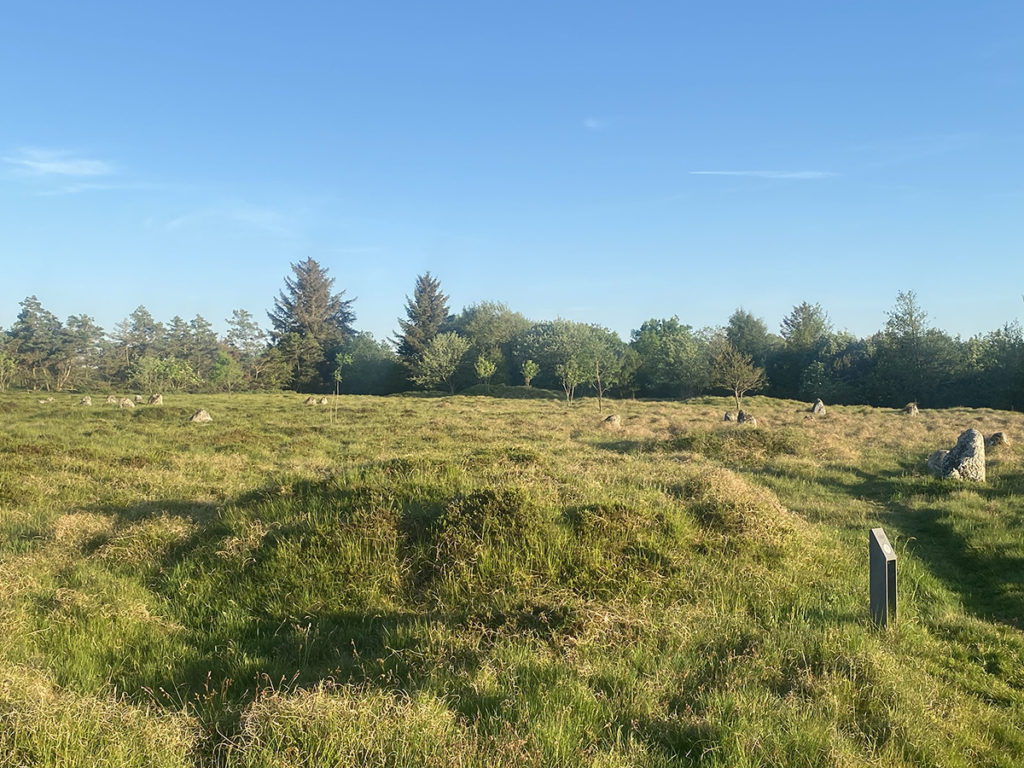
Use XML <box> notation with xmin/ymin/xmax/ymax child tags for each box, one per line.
<box><xmin>0</xmin><ymin>258</ymin><xmax>1024</xmax><ymax>410</ymax></box>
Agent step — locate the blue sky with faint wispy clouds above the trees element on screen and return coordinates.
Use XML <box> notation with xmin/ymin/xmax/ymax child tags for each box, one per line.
<box><xmin>0</xmin><ymin>0</ymin><xmax>1024</xmax><ymax>338</ymax></box>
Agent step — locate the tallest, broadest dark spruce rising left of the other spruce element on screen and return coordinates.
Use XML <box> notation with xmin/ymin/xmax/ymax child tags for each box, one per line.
<box><xmin>267</xmin><ymin>258</ymin><xmax>355</xmax><ymax>391</ymax></box>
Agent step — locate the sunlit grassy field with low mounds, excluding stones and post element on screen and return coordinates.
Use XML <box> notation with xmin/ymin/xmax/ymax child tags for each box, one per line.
<box><xmin>0</xmin><ymin>393</ymin><xmax>1024</xmax><ymax>768</ymax></box>
